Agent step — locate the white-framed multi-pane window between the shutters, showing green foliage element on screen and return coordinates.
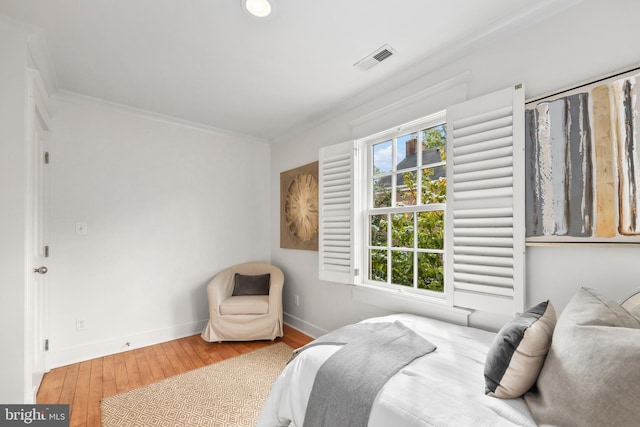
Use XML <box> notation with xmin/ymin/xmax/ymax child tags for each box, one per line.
<box><xmin>363</xmin><ymin>114</ymin><xmax>447</xmax><ymax>295</ymax></box>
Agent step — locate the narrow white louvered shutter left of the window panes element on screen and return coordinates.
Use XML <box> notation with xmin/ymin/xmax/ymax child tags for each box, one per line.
<box><xmin>318</xmin><ymin>141</ymin><xmax>356</xmax><ymax>284</ymax></box>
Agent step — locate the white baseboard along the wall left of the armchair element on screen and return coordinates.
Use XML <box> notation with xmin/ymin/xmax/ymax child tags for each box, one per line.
<box><xmin>48</xmin><ymin>320</ymin><xmax>207</xmax><ymax>369</ymax></box>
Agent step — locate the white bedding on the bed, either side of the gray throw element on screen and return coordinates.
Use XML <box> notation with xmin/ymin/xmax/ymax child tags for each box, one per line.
<box><xmin>257</xmin><ymin>314</ymin><xmax>536</xmax><ymax>427</ymax></box>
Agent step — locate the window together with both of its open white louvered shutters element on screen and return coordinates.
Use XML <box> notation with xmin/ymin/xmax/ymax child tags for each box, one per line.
<box><xmin>319</xmin><ymin>85</ymin><xmax>525</xmax><ymax>314</ymax></box>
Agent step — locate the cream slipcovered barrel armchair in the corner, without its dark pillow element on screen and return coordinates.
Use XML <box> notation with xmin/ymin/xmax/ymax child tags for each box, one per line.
<box><xmin>201</xmin><ymin>262</ymin><xmax>284</xmax><ymax>342</ymax></box>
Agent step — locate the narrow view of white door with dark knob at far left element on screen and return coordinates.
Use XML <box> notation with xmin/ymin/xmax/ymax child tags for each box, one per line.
<box><xmin>25</xmin><ymin>68</ymin><xmax>50</xmax><ymax>403</ymax></box>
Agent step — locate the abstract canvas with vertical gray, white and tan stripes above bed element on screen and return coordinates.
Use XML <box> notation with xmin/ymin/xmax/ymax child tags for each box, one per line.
<box><xmin>525</xmin><ymin>65</ymin><xmax>640</xmax><ymax>243</ymax></box>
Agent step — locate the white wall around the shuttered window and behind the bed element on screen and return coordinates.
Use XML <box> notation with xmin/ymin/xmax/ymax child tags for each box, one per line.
<box><xmin>271</xmin><ymin>0</ymin><xmax>640</xmax><ymax>335</ymax></box>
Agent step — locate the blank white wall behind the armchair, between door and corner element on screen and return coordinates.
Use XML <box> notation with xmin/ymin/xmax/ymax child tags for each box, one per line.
<box><xmin>47</xmin><ymin>97</ymin><xmax>271</xmax><ymax>367</ymax></box>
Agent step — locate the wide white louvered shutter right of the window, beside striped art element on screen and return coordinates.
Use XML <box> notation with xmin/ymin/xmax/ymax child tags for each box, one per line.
<box><xmin>445</xmin><ymin>85</ymin><xmax>525</xmax><ymax>315</ymax></box>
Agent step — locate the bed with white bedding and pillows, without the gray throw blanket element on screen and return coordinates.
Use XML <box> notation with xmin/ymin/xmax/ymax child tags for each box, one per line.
<box><xmin>257</xmin><ymin>288</ymin><xmax>640</xmax><ymax>427</ymax></box>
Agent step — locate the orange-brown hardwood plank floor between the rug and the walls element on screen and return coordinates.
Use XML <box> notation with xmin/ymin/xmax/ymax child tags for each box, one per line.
<box><xmin>37</xmin><ymin>325</ymin><xmax>311</xmax><ymax>426</ymax></box>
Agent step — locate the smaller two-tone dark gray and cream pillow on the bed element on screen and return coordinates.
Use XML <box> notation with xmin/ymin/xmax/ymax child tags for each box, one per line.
<box><xmin>484</xmin><ymin>301</ymin><xmax>556</xmax><ymax>399</ymax></box>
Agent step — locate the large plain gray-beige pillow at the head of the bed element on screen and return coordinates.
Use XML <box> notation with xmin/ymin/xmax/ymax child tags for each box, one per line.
<box><xmin>525</xmin><ymin>288</ymin><xmax>640</xmax><ymax>427</ymax></box>
